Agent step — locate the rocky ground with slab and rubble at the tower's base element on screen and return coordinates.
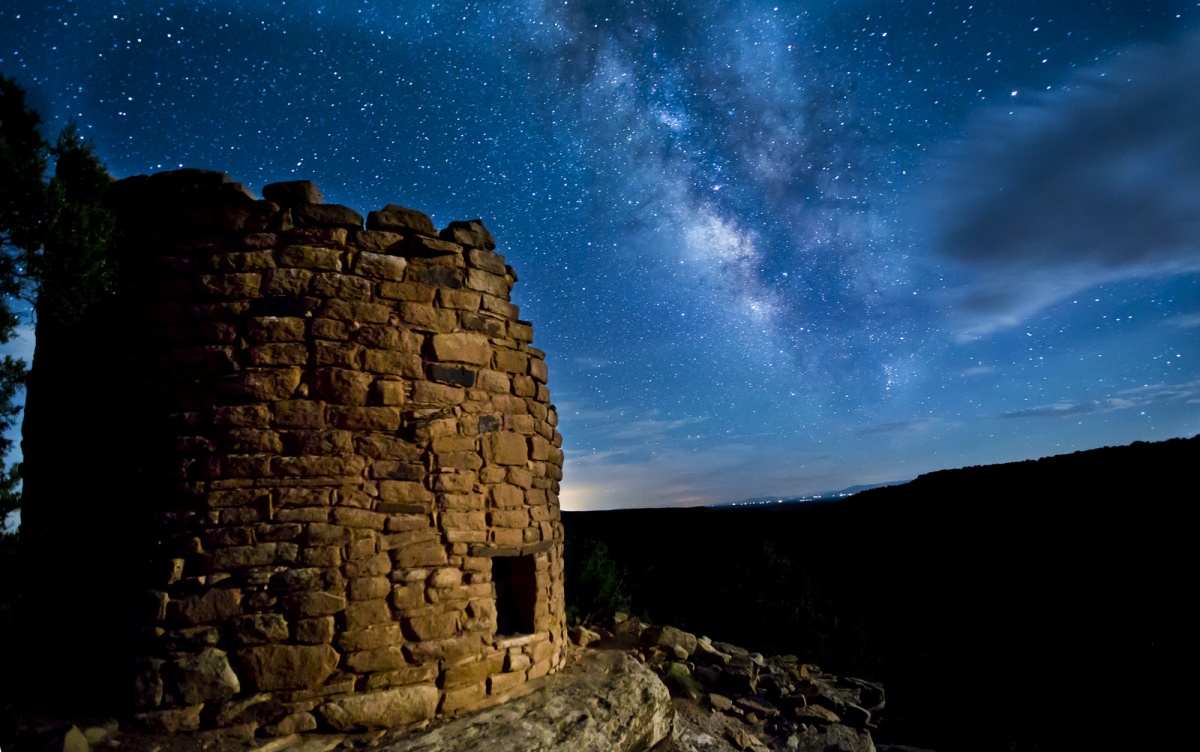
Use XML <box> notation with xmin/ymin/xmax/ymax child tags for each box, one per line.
<box><xmin>4</xmin><ymin>614</ymin><xmax>920</xmax><ymax>752</ymax></box>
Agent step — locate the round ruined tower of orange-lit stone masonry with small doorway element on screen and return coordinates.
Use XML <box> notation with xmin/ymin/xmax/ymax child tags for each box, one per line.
<box><xmin>75</xmin><ymin>170</ymin><xmax>565</xmax><ymax>735</ymax></box>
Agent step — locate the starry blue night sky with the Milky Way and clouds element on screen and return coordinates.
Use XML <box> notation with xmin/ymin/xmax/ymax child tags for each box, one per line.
<box><xmin>0</xmin><ymin>0</ymin><xmax>1200</xmax><ymax>509</ymax></box>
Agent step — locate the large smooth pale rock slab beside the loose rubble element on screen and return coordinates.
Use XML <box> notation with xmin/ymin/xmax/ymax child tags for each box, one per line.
<box><xmin>377</xmin><ymin>650</ymin><xmax>674</xmax><ymax>752</ymax></box>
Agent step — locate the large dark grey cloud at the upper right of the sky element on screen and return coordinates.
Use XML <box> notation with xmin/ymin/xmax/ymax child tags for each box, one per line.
<box><xmin>925</xmin><ymin>36</ymin><xmax>1200</xmax><ymax>339</ymax></box>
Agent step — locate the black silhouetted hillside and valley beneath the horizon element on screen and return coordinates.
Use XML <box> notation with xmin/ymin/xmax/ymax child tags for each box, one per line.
<box><xmin>564</xmin><ymin>437</ymin><xmax>1200</xmax><ymax>752</ymax></box>
